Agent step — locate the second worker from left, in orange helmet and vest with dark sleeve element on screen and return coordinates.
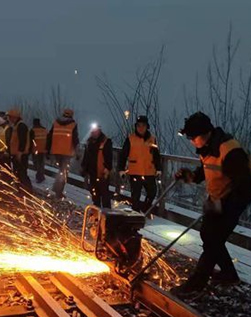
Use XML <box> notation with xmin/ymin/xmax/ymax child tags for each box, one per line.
<box><xmin>7</xmin><ymin>109</ymin><xmax>32</xmax><ymax>191</ymax></box>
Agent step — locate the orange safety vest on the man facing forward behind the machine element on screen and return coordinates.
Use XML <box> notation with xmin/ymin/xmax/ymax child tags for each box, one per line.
<box><xmin>128</xmin><ymin>133</ymin><xmax>157</xmax><ymax>176</ymax></box>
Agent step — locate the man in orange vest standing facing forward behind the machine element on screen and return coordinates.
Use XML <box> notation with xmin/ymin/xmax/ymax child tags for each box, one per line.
<box><xmin>119</xmin><ymin>116</ymin><xmax>161</xmax><ymax>212</ymax></box>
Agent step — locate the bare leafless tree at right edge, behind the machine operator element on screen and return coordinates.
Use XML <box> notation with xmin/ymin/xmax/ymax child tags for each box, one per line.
<box><xmin>184</xmin><ymin>24</ymin><xmax>251</xmax><ymax>151</ymax></box>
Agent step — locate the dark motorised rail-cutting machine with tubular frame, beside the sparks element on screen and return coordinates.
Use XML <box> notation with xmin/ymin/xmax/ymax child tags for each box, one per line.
<box><xmin>81</xmin><ymin>205</ymin><xmax>145</xmax><ymax>275</ymax></box>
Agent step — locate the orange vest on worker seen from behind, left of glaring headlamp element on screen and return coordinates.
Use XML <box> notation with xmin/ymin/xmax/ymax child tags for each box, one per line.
<box><xmin>51</xmin><ymin>121</ymin><xmax>76</xmax><ymax>156</ymax></box>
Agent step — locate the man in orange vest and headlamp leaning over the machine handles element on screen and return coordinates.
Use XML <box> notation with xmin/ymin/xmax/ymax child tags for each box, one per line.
<box><xmin>172</xmin><ymin>112</ymin><xmax>251</xmax><ymax>298</ymax></box>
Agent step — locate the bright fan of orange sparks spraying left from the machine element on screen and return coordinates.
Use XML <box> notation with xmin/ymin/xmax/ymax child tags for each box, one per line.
<box><xmin>0</xmin><ymin>166</ymin><xmax>109</xmax><ymax>274</ymax></box>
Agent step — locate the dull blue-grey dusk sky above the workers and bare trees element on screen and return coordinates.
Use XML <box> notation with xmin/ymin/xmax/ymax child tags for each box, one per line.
<box><xmin>0</xmin><ymin>0</ymin><xmax>251</xmax><ymax>134</ymax></box>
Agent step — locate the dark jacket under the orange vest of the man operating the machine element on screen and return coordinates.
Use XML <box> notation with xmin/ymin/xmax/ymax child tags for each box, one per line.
<box><xmin>194</xmin><ymin>127</ymin><xmax>251</xmax><ymax>204</ymax></box>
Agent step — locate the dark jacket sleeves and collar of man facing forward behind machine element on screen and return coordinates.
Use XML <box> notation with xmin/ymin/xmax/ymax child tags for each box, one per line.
<box><xmin>118</xmin><ymin>130</ymin><xmax>161</xmax><ymax>171</ymax></box>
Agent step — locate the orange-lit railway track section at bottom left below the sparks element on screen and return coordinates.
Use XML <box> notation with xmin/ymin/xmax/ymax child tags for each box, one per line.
<box><xmin>0</xmin><ymin>273</ymin><xmax>121</xmax><ymax>317</ymax></box>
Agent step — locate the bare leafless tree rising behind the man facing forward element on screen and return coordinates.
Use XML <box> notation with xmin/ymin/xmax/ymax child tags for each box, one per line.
<box><xmin>97</xmin><ymin>46</ymin><xmax>166</xmax><ymax>150</ymax></box>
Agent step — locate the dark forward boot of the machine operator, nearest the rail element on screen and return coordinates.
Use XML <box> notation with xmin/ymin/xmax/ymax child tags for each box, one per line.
<box><xmin>170</xmin><ymin>274</ymin><xmax>207</xmax><ymax>299</ymax></box>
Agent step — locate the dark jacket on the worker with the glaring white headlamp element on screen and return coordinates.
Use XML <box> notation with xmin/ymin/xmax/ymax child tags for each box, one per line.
<box><xmin>81</xmin><ymin>133</ymin><xmax>112</xmax><ymax>179</ymax></box>
